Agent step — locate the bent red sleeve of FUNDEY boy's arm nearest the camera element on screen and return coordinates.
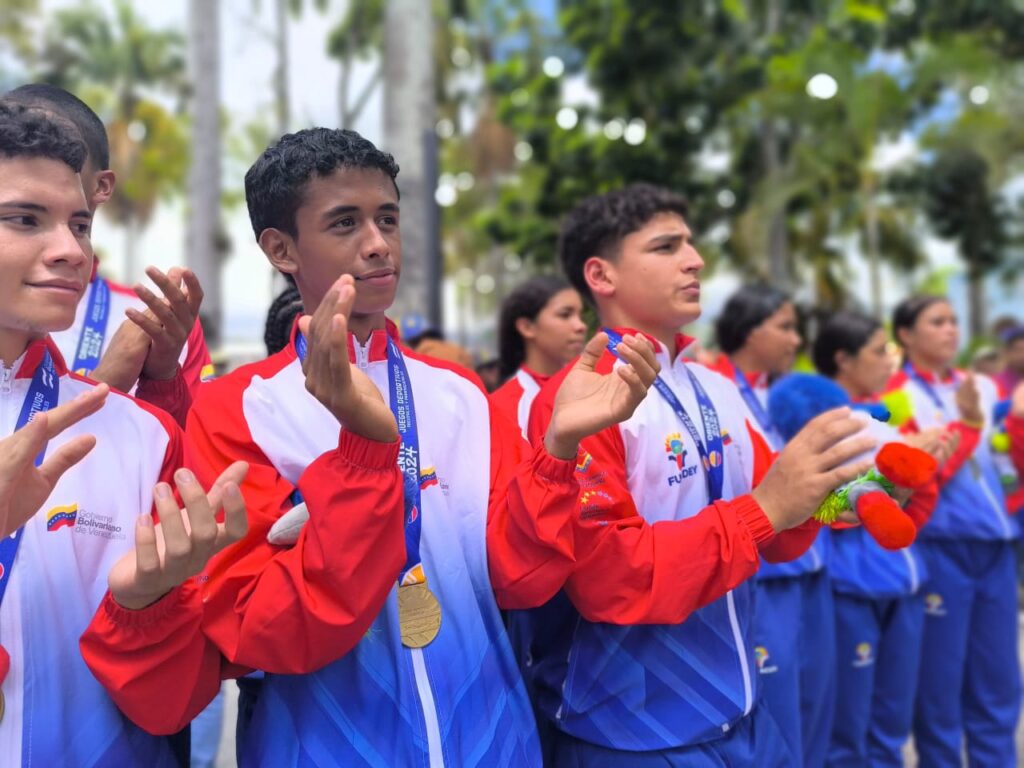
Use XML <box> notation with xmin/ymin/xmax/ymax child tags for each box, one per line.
<box><xmin>529</xmin><ymin>355</ymin><xmax>774</xmax><ymax>624</ymax></box>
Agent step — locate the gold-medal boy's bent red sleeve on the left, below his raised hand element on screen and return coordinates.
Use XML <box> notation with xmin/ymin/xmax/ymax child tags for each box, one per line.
<box><xmin>185</xmin><ymin>366</ymin><xmax>406</xmax><ymax>674</ymax></box>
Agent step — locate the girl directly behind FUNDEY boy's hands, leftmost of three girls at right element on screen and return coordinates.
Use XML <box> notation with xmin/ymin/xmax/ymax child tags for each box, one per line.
<box><xmin>715</xmin><ymin>284</ymin><xmax>836</xmax><ymax>768</ymax></box>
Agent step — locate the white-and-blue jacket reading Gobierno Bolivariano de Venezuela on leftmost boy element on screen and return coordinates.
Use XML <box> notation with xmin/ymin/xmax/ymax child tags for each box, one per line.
<box><xmin>0</xmin><ymin>339</ymin><xmax>182</xmax><ymax>768</ymax></box>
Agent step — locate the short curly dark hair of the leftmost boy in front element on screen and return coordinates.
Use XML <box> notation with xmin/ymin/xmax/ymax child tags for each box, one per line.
<box><xmin>0</xmin><ymin>100</ymin><xmax>85</xmax><ymax>173</ymax></box>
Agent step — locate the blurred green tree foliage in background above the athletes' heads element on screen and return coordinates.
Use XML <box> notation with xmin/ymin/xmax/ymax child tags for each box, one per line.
<box><xmin>6</xmin><ymin>0</ymin><xmax>1024</xmax><ymax>352</ymax></box>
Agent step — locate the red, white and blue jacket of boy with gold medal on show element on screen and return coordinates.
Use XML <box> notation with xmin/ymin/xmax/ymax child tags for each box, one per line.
<box><xmin>83</xmin><ymin>324</ymin><xmax>580</xmax><ymax>765</ymax></box>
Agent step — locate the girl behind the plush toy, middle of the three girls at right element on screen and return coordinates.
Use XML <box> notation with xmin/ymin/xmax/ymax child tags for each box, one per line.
<box><xmin>812</xmin><ymin>311</ymin><xmax>953</xmax><ymax>768</ymax></box>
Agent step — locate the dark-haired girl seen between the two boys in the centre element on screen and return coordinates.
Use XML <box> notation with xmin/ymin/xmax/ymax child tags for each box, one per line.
<box><xmin>490</xmin><ymin>274</ymin><xmax>587</xmax><ymax>435</ymax></box>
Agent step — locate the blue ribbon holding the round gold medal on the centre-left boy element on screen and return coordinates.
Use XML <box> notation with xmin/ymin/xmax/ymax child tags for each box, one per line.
<box><xmin>292</xmin><ymin>334</ymin><xmax>425</xmax><ymax>585</ymax></box>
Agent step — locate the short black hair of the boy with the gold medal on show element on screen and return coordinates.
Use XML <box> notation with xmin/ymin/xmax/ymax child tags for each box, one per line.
<box><xmin>246</xmin><ymin>128</ymin><xmax>398</xmax><ymax>241</ymax></box>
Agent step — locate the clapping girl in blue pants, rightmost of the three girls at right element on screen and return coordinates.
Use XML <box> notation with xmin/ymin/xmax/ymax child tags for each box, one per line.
<box><xmin>885</xmin><ymin>296</ymin><xmax>1021</xmax><ymax>766</ymax></box>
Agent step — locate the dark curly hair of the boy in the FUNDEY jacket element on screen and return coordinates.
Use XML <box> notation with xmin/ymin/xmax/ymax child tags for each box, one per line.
<box><xmin>558</xmin><ymin>183</ymin><xmax>689</xmax><ymax>302</ymax></box>
